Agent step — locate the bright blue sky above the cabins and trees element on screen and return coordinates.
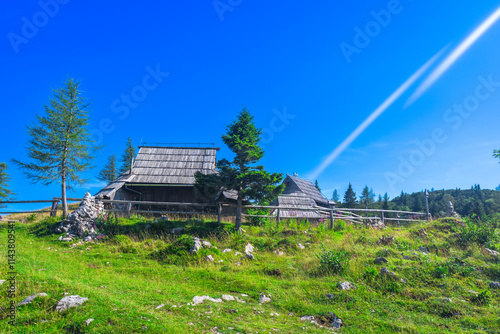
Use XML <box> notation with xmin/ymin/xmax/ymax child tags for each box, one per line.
<box><xmin>0</xmin><ymin>0</ymin><xmax>500</xmax><ymax>208</ymax></box>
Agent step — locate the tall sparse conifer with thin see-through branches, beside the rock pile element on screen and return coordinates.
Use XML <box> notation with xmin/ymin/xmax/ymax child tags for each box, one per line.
<box><xmin>13</xmin><ymin>79</ymin><xmax>99</xmax><ymax>216</ymax></box>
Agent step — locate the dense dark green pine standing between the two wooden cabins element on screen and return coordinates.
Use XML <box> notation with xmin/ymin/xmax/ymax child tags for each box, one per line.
<box><xmin>195</xmin><ymin>108</ymin><xmax>284</xmax><ymax>231</ymax></box>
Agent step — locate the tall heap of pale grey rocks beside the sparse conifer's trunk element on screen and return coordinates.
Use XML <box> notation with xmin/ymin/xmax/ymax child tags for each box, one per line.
<box><xmin>55</xmin><ymin>192</ymin><xmax>106</xmax><ymax>241</ymax></box>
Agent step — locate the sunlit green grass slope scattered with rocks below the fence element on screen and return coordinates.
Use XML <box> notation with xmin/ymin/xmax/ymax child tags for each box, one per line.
<box><xmin>0</xmin><ymin>217</ymin><xmax>500</xmax><ymax>333</ymax></box>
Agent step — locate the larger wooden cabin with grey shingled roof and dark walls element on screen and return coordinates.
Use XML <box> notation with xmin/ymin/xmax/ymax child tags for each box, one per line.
<box><xmin>96</xmin><ymin>146</ymin><xmax>219</xmax><ymax>203</ymax></box>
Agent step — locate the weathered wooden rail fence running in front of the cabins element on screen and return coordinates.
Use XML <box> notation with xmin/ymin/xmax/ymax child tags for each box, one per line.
<box><xmin>0</xmin><ymin>197</ymin><xmax>429</xmax><ymax>228</ymax></box>
